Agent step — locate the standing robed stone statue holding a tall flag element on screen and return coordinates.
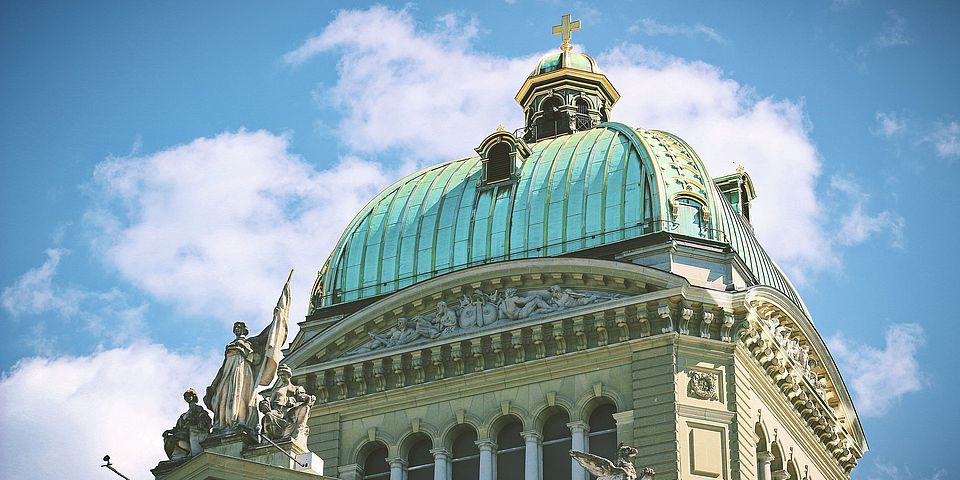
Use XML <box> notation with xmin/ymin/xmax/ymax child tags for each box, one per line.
<box><xmin>203</xmin><ymin>271</ymin><xmax>293</xmax><ymax>435</ymax></box>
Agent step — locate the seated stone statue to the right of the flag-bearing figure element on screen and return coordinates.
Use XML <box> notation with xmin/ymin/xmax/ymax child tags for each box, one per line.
<box><xmin>259</xmin><ymin>365</ymin><xmax>317</xmax><ymax>446</ymax></box>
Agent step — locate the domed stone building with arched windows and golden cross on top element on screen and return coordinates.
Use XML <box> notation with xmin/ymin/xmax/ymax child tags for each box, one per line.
<box><xmin>156</xmin><ymin>16</ymin><xmax>867</xmax><ymax>480</ymax></box>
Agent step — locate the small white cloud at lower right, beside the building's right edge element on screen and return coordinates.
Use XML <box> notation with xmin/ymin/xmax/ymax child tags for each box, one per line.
<box><xmin>827</xmin><ymin>323</ymin><xmax>925</xmax><ymax>417</ymax></box>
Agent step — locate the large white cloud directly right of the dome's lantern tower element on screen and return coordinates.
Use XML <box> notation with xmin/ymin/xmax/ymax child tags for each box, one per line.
<box><xmin>599</xmin><ymin>46</ymin><xmax>838</xmax><ymax>283</ymax></box>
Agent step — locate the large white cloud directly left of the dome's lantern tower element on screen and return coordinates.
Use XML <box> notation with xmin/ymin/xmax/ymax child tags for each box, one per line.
<box><xmin>284</xmin><ymin>7</ymin><xmax>539</xmax><ymax>163</ymax></box>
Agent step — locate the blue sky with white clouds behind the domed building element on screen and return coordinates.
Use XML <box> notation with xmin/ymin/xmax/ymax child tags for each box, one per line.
<box><xmin>0</xmin><ymin>0</ymin><xmax>960</xmax><ymax>479</ymax></box>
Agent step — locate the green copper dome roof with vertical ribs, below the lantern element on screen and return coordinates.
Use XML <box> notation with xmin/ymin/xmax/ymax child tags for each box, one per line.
<box><xmin>314</xmin><ymin>122</ymin><xmax>803</xmax><ymax>314</ymax></box>
